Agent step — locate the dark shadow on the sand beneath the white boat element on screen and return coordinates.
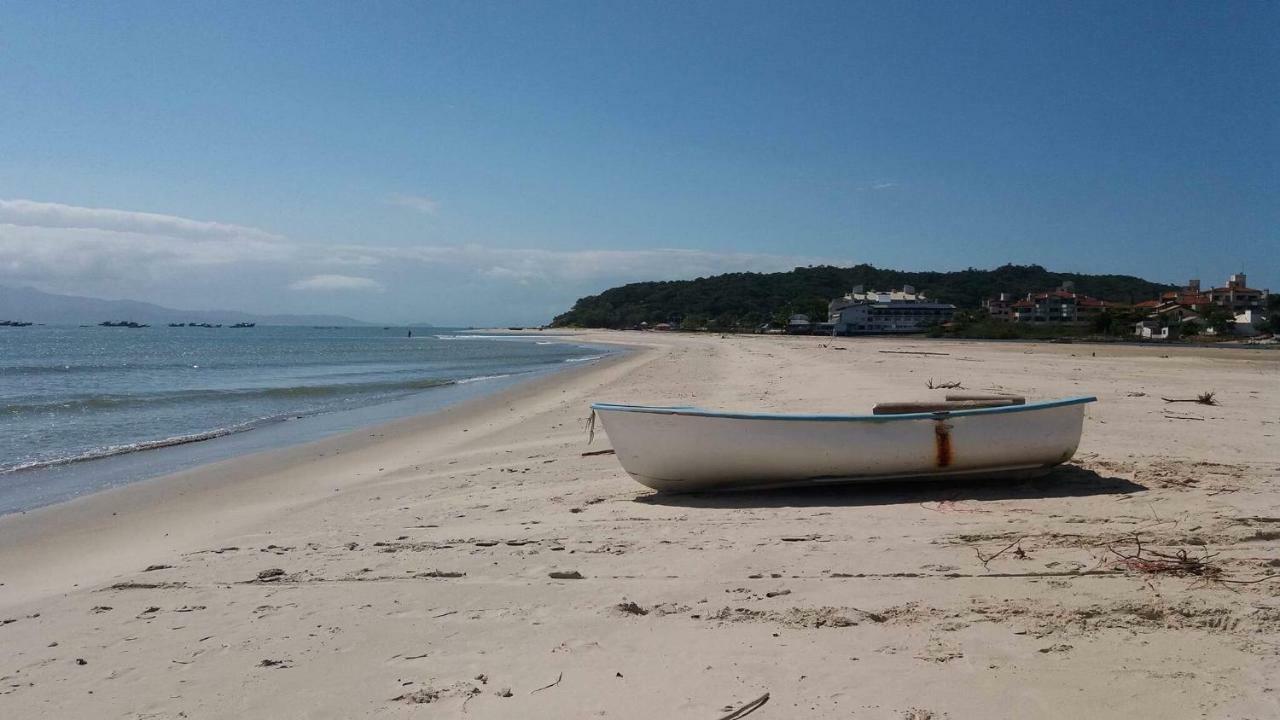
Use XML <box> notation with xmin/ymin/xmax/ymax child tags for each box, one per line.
<box><xmin>635</xmin><ymin>465</ymin><xmax>1148</xmax><ymax>510</ymax></box>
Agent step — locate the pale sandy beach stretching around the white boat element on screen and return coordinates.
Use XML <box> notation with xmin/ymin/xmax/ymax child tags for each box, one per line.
<box><xmin>0</xmin><ymin>333</ymin><xmax>1280</xmax><ymax>720</ymax></box>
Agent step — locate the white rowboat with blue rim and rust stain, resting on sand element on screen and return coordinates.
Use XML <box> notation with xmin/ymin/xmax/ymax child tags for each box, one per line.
<box><xmin>591</xmin><ymin>397</ymin><xmax>1097</xmax><ymax>492</ymax></box>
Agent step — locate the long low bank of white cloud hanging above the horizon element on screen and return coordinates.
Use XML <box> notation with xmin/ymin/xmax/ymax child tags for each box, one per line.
<box><xmin>0</xmin><ymin>200</ymin><xmax>849</xmax><ymax>319</ymax></box>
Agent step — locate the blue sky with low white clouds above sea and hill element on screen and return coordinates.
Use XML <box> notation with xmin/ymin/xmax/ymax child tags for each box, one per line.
<box><xmin>0</xmin><ymin>0</ymin><xmax>1280</xmax><ymax>325</ymax></box>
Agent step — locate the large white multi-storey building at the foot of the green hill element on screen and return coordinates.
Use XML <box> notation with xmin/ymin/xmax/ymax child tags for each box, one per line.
<box><xmin>828</xmin><ymin>284</ymin><xmax>956</xmax><ymax>334</ymax></box>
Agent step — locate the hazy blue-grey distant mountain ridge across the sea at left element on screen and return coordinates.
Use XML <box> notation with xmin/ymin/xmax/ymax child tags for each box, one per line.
<box><xmin>0</xmin><ymin>286</ymin><xmax>374</xmax><ymax>325</ymax></box>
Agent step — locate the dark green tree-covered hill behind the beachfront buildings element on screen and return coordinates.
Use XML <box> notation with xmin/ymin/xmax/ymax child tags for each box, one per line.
<box><xmin>552</xmin><ymin>265</ymin><xmax>1174</xmax><ymax>328</ymax></box>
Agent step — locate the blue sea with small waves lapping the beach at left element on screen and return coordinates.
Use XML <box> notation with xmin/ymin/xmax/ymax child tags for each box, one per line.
<box><xmin>0</xmin><ymin>327</ymin><xmax>611</xmax><ymax>512</ymax></box>
